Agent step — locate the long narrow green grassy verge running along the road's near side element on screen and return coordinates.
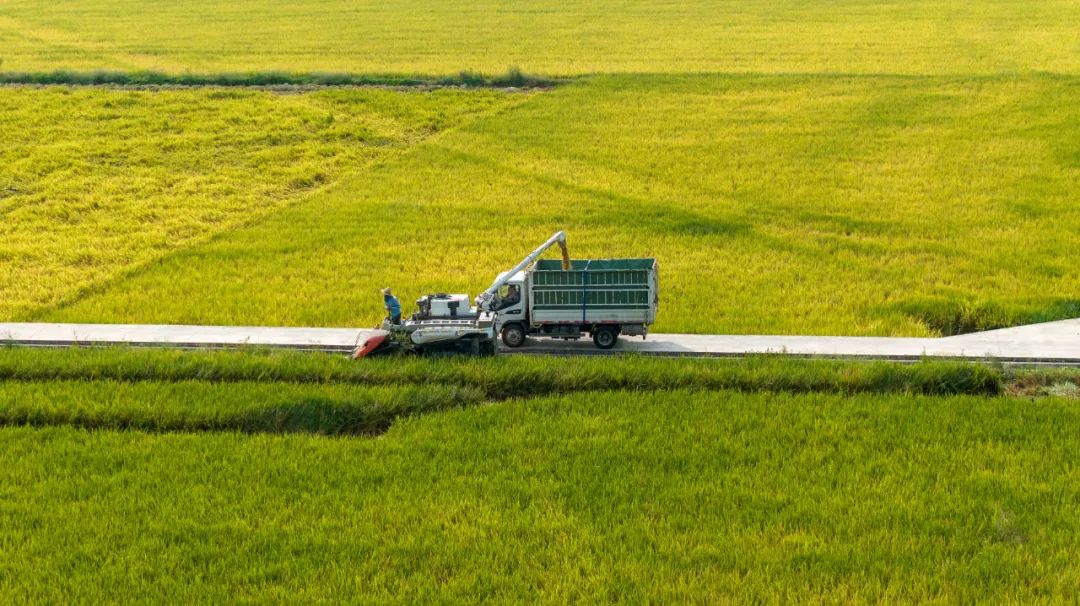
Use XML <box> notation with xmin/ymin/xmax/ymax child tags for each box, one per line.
<box><xmin>0</xmin><ymin>347</ymin><xmax>1002</xmax><ymax>399</ymax></box>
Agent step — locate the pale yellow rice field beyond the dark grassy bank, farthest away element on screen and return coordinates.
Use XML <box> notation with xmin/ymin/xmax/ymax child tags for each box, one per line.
<box><xmin>0</xmin><ymin>0</ymin><xmax>1080</xmax><ymax>76</ymax></box>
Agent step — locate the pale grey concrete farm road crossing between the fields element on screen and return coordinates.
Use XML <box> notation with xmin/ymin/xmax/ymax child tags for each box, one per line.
<box><xmin>0</xmin><ymin>319</ymin><xmax>1080</xmax><ymax>366</ymax></box>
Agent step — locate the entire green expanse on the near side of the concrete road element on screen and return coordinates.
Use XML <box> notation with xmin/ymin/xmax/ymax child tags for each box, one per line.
<box><xmin>0</xmin><ymin>350</ymin><xmax>1080</xmax><ymax>603</ymax></box>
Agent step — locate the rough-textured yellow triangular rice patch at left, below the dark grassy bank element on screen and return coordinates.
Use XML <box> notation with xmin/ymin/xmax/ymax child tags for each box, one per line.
<box><xmin>0</xmin><ymin>87</ymin><xmax>520</xmax><ymax>321</ymax></box>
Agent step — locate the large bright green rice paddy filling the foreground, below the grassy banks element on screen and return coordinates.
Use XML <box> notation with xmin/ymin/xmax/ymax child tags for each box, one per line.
<box><xmin>8</xmin><ymin>386</ymin><xmax>1080</xmax><ymax>603</ymax></box>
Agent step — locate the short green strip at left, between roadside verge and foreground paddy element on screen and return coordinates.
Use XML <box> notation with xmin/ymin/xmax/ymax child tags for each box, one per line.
<box><xmin>0</xmin><ymin>380</ymin><xmax>483</xmax><ymax>435</ymax></box>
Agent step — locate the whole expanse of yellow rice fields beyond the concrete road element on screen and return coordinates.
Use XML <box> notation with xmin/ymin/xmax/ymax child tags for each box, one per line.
<box><xmin>0</xmin><ymin>0</ymin><xmax>1080</xmax><ymax>335</ymax></box>
